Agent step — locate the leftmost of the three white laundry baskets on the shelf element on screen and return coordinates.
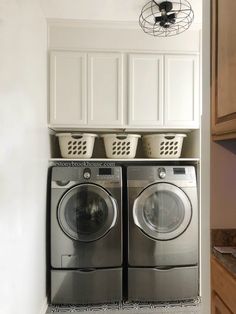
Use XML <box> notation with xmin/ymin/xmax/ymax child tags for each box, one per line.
<box><xmin>56</xmin><ymin>133</ymin><xmax>97</xmax><ymax>159</ymax></box>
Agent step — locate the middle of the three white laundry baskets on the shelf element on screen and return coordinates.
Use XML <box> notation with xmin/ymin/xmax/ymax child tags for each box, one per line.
<box><xmin>102</xmin><ymin>134</ymin><xmax>141</xmax><ymax>159</ymax></box>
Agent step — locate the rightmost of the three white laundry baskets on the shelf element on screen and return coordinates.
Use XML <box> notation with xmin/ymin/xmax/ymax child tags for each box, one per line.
<box><xmin>142</xmin><ymin>133</ymin><xmax>186</xmax><ymax>158</ymax></box>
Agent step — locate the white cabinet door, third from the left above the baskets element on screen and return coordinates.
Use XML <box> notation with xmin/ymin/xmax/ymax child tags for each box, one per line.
<box><xmin>128</xmin><ymin>54</ymin><xmax>163</xmax><ymax>127</ymax></box>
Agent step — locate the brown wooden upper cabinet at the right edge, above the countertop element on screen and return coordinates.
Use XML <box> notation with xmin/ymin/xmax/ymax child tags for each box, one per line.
<box><xmin>211</xmin><ymin>0</ymin><xmax>236</xmax><ymax>139</ymax></box>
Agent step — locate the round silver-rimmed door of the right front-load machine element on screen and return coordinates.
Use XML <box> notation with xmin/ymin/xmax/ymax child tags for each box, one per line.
<box><xmin>133</xmin><ymin>183</ymin><xmax>192</xmax><ymax>240</ymax></box>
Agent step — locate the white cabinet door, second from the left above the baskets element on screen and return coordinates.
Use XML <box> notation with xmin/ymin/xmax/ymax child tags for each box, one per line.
<box><xmin>88</xmin><ymin>53</ymin><xmax>123</xmax><ymax>127</ymax></box>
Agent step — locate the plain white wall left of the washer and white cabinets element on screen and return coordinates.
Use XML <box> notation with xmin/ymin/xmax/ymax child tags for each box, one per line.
<box><xmin>0</xmin><ymin>0</ymin><xmax>49</xmax><ymax>314</ymax></box>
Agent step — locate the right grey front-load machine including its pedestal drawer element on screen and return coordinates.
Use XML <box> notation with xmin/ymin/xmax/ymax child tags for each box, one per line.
<box><xmin>127</xmin><ymin>165</ymin><xmax>199</xmax><ymax>301</ymax></box>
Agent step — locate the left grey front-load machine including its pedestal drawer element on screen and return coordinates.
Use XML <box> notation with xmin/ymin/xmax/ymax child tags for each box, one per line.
<box><xmin>50</xmin><ymin>166</ymin><xmax>123</xmax><ymax>304</ymax></box>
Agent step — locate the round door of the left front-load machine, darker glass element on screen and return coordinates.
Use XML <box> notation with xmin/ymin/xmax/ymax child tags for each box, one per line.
<box><xmin>58</xmin><ymin>184</ymin><xmax>117</xmax><ymax>242</ymax></box>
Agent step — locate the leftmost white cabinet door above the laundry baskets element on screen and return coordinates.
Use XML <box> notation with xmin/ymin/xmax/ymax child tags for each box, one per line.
<box><xmin>50</xmin><ymin>51</ymin><xmax>87</xmax><ymax>126</ymax></box>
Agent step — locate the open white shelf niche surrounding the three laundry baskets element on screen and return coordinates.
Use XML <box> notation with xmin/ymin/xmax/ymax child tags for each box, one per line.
<box><xmin>49</xmin><ymin>129</ymin><xmax>200</xmax><ymax>161</ymax></box>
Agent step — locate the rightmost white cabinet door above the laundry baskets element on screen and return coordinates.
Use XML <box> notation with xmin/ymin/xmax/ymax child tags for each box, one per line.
<box><xmin>164</xmin><ymin>55</ymin><xmax>200</xmax><ymax>128</ymax></box>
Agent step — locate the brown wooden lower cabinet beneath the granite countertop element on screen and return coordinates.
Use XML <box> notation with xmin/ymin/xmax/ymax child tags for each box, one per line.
<box><xmin>211</xmin><ymin>256</ymin><xmax>236</xmax><ymax>314</ymax></box>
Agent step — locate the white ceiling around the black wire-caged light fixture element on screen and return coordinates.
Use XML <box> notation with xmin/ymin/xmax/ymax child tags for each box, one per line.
<box><xmin>39</xmin><ymin>0</ymin><xmax>203</xmax><ymax>24</ymax></box>
